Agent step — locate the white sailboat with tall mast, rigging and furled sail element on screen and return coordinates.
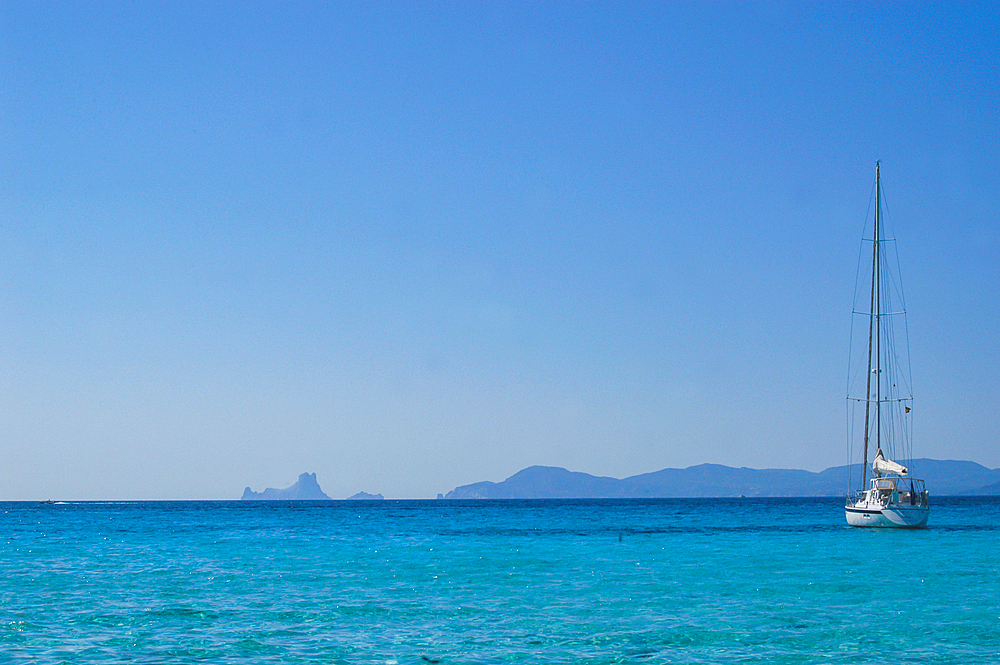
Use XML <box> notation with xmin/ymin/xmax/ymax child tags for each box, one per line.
<box><xmin>846</xmin><ymin>162</ymin><xmax>930</xmax><ymax>528</ymax></box>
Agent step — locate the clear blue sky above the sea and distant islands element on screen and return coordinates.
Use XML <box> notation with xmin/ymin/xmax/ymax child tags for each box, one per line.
<box><xmin>0</xmin><ymin>2</ymin><xmax>1000</xmax><ymax>499</ymax></box>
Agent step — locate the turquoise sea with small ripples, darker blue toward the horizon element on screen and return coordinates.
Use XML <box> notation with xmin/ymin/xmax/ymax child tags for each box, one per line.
<box><xmin>0</xmin><ymin>497</ymin><xmax>1000</xmax><ymax>665</ymax></box>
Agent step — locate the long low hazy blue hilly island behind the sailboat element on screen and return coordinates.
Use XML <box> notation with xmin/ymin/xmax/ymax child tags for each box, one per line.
<box><xmin>438</xmin><ymin>459</ymin><xmax>1000</xmax><ymax>499</ymax></box>
